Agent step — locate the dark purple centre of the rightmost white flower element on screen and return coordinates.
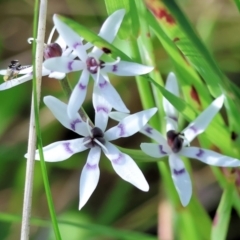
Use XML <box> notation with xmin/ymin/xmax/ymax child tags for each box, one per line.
<box><xmin>167</xmin><ymin>130</ymin><xmax>184</xmax><ymax>153</ymax></box>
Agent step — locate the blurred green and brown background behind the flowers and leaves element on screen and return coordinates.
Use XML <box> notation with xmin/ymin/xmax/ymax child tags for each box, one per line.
<box><xmin>0</xmin><ymin>0</ymin><xmax>240</xmax><ymax>240</ymax></box>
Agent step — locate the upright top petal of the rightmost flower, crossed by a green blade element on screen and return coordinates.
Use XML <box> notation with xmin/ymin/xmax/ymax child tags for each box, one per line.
<box><xmin>163</xmin><ymin>72</ymin><xmax>179</xmax><ymax>132</ymax></box>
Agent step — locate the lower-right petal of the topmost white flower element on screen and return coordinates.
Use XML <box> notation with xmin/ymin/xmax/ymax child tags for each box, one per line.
<box><xmin>92</xmin><ymin>74</ymin><xmax>129</xmax><ymax>113</ymax></box>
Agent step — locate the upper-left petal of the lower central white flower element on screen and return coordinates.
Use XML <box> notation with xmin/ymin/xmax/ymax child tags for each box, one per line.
<box><xmin>43</xmin><ymin>96</ymin><xmax>89</xmax><ymax>136</ymax></box>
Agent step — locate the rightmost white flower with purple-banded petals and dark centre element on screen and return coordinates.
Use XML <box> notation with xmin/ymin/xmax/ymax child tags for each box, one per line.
<box><xmin>123</xmin><ymin>73</ymin><xmax>240</xmax><ymax>206</ymax></box>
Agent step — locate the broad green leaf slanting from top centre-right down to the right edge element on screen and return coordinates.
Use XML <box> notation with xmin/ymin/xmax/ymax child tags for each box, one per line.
<box><xmin>159</xmin><ymin>0</ymin><xmax>240</xmax><ymax>131</ymax></box>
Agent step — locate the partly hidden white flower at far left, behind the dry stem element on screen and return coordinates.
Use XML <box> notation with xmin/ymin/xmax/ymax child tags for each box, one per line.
<box><xmin>0</xmin><ymin>27</ymin><xmax>75</xmax><ymax>91</ymax></box>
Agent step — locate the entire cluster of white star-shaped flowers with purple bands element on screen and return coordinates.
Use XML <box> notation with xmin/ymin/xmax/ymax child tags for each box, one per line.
<box><xmin>0</xmin><ymin>9</ymin><xmax>240</xmax><ymax>209</ymax></box>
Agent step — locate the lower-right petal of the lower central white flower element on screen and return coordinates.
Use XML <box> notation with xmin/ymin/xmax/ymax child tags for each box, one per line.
<box><xmin>104</xmin><ymin>142</ymin><xmax>149</xmax><ymax>192</ymax></box>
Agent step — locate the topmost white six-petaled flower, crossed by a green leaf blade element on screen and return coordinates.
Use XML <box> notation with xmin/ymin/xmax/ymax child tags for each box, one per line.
<box><xmin>44</xmin><ymin>9</ymin><xmax>153</xmax><ymax>116</ymax></box>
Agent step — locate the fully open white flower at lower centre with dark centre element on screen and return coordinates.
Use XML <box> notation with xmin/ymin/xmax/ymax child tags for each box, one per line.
<box><xmin>25</xmin><ymin>90</ymin><xmax>157</xmax><ymax>209</ymax></box>
